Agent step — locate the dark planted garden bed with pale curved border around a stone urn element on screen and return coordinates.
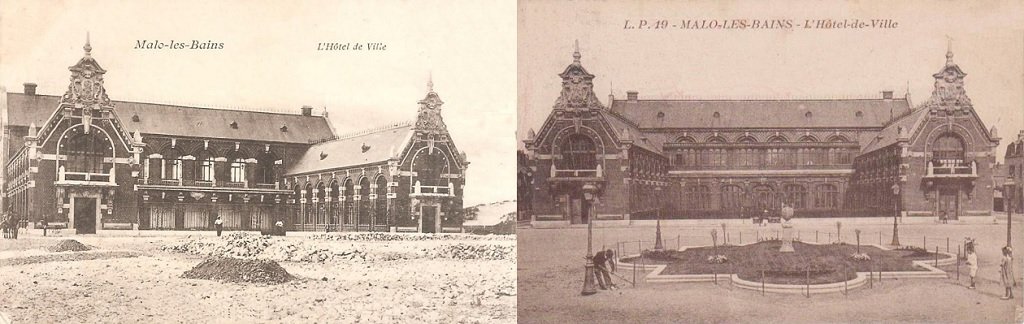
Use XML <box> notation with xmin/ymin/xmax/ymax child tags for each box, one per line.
<box><xmin>623</xmin><ymin>240</ymin><xmax>947</xmax><ymax>284</ymax></box>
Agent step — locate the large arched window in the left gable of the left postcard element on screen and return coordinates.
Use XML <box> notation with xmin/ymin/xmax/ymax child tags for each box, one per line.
<box><xmin>62</xmin><ymin>131</ymin><xmax>114</xmax><ymax>173</ymax></box>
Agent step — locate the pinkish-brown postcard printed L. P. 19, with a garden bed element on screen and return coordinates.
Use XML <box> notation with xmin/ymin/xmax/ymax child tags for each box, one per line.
<box><xmin>516</xmin><ymin>0</ymin><xmax>1024</xmax><ymax>323</ymax></box>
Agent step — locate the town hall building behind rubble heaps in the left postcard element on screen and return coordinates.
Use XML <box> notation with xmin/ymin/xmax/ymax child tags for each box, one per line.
<box><xmin>0</xmin><ymin>42</ymin><xmax>469</xmax><ymax>234</ymax></box>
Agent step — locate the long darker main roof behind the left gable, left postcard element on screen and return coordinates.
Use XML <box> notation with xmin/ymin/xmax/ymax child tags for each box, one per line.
<box><xmin>7</xmin><ymin>93</ymin><xmax>334</xmax><ymax>144</ymax></box>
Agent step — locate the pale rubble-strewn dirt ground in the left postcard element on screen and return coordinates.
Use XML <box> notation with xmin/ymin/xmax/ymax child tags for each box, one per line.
<box><xmin>0</xmin><ymin>232</ymin><xmax>516</xmax><ymax>323</ymax></box>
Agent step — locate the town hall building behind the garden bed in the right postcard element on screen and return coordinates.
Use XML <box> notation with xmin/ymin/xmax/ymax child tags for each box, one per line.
<box><xmin>519</xmin><ymin>43</ymin><xmax>999</xmax><ymax>226</ymax></box>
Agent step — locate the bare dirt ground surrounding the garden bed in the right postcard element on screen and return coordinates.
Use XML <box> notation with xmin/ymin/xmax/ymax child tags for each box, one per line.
<box><xmin>517</xmin><ymin>221</ymin><xmax>1024</xmax><ymax>323</ymax></box>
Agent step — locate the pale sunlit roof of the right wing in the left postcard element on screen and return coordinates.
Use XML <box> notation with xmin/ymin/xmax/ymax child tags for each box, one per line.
<box><xmin>285</xmin><ymin>122</ymin><xmax>413</xmax><ymax>175</ymax></box>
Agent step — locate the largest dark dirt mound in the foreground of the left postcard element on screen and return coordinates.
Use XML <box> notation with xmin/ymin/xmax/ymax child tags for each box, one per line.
<box><xmin>181</xmin><ymin>257</ymin><xmax>295</xmax><ymax>284</ymax></box>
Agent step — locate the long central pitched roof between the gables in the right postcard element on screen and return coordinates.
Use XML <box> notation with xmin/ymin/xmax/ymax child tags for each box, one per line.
<box><xmin>611</xmin><ymin>98</ymin><xmax>910</xmax><ymax>128</ymax></box>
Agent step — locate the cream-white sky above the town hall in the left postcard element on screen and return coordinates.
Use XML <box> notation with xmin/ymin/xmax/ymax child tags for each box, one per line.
<box><xmin>0</xmin><ymin>0</ymin><xmax>516</xmax><ymax>206</ymax></box>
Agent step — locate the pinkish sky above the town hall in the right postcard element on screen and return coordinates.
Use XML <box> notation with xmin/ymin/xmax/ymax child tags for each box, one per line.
<box><xmin>518</xmin><ymin>1</ymin><xmax>1024</xmax><ymax>161</ymax></box>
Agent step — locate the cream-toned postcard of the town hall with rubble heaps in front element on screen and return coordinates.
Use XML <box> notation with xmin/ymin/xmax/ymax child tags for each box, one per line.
<box><xmin>0</xmin><ymin>0</ymin><xmax>517</xmax><ymax>323</ymax></box>
